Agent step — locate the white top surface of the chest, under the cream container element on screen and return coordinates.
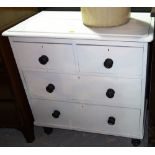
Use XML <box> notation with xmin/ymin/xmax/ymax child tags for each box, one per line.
<box><xmin>2</xmin><ymin>11</ymin><xmax>154</xmax><ymax>42</ymax></box>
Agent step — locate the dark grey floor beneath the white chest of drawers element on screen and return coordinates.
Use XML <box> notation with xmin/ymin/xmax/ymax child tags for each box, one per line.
<box><xmin>0</xmin><ymin>123</ymin><xmax>148</xmax><ymax>147</ymax></box>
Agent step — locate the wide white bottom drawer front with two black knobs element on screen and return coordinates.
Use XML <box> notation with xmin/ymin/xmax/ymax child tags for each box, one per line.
<box><xmin>31</xmin><ymin>99</ymin><xmax>140</xmax><ymax>137</ymax></box>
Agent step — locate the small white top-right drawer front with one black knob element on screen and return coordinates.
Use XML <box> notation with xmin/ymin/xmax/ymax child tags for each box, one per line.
<box><xmin>77</xmin><ymin>45</ymin><xmax>143</xmax><ymax>76</ymax></box>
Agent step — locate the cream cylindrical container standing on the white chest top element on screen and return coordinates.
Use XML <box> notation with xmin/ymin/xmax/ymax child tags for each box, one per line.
<box><xmin>81</xmin><ymin>7</ymin><xmax>130</xmax><ymax>27</ymax></box>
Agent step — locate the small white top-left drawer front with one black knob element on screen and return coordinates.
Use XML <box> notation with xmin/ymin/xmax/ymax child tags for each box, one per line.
<box><xmin>13</xmin><ymin>43</ymin><xmax>75</xmax><ymax>72</ymax></box>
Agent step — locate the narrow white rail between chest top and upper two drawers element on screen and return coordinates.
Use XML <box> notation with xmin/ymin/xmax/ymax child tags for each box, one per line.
<box><xmin>9</xmin><ymin>37</ymin><xmax>144</xmax><ymax>48</ymax></box>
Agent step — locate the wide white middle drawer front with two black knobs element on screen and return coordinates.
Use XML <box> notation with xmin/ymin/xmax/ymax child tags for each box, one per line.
<box><xmin>25</xmin><ymin>72</ymin><xmax>141</xmax><ymax>108</ymax></box>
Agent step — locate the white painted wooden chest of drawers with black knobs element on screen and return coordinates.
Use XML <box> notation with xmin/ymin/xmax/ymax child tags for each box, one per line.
<box><xmin>3</xmin><ymin>11</ymin><xmax>154</xmax><ymax>145</ymax></box>
